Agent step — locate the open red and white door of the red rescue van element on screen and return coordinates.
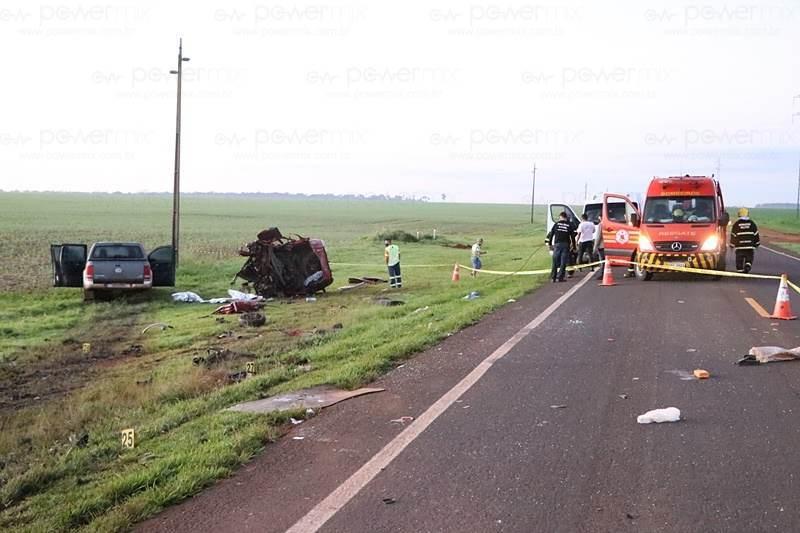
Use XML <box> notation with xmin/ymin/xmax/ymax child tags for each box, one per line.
<box><xmin>601</xmin><ymin>193</ymin><xmax>641</xmax><ymax>264</ymax></box>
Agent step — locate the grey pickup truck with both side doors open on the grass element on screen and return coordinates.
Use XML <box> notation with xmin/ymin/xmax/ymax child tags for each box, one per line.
<box><xmin>50</xmin><ymin>242</ymin><xmax>175</xmax><ymax>300</ymax></box>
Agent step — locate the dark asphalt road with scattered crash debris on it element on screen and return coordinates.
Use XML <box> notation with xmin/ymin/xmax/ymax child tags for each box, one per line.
<box><xmin>140</xmin><ymin>246</ymin><xmax>800</xmax><ymax>533</ymax></box>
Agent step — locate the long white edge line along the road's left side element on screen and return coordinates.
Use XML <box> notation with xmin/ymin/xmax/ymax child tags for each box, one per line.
<box><xmin>286</xmin><ymin>273</ymin><xmax>594</xmax><ymax>533</ymax></box>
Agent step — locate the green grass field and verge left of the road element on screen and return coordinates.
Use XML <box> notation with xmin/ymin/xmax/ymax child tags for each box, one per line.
<box><xmin>0</xmin><ymin>193</ymin><xmax>549</xmax><ymax>531</ymax></box>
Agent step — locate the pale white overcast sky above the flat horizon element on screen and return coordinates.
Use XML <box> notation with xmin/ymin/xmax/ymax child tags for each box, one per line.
<box><xmin>0</xmin><ymin>0</ymin><xmax>800</xmax><ymax>205</ymax></box>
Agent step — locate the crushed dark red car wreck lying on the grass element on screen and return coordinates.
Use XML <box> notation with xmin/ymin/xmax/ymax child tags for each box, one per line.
<box><xmin>233</xmin><ymin>228</ymin><xmax>333</xmax><ymax>298</ymax></box>
